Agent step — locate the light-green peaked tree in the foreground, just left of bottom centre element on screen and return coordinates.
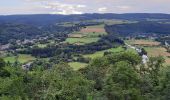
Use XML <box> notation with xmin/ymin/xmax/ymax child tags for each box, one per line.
<box><xmin>42</xmin><ymin>64</ymin><xmax>92</xmax><ymax>100</ymax></box>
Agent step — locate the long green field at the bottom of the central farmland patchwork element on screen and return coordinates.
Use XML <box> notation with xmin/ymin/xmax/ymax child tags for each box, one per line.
<box><xmin>66</xmin><ymin>37</ymin><xmax>100</xmax><ymax>45</ymax></box>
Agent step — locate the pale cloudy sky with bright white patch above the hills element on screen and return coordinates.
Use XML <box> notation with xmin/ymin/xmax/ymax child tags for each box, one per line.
<box><xmin>0</xmin><ymin>0</ymin><xmax>170</xmax><ymax>15</ymax></box>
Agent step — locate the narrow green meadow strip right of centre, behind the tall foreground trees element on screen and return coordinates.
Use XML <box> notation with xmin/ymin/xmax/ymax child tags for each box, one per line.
<box><xmin>84</xmin><ymin>47</ymin><xmax>124</xmax><ymax>59</ymax></box>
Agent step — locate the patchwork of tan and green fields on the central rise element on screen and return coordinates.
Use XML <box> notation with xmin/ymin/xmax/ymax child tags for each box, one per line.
<box><xmin>65</xmin><ymin>24</ymin><xmax>107</xmax><ymax>45</ymax></box>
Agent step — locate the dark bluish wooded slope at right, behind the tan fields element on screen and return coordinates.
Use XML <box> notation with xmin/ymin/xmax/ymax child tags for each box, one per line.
<box><xmin>106</xmin><ymin>21</ymin><xmax>170</xmax><ymax>36</ymax></box>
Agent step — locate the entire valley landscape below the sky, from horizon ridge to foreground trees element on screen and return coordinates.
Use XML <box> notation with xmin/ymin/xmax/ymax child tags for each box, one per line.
<box><xmin>0</xmin><ymin>13</ymin><xmax>170</xmax><ymax>100</ymax></box>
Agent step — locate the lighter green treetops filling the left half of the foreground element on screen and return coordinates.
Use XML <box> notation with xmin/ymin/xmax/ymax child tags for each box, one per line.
<box><xmin>0</xmin><ymin>64</ymin><xmax>93</xmax><ymax>100</ymax></box>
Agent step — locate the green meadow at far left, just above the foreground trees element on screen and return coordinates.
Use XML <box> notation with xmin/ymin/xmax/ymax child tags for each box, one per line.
<box><xmin>4</xmin><ymin>54</ymin><xmax>36</xmax><ymax>63</ymax></box>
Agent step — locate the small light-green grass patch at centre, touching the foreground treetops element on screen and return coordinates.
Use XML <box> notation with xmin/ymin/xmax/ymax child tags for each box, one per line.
<box><xmin>68</xmin><ymin>62</ymin><xmax>87</xmax><ymax>70</ymax></box>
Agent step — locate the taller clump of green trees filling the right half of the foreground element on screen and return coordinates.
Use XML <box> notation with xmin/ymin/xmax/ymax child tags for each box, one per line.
<box><xmin>80</xmin><ymin>52</ymin><xmax>170</xmax><ymax>100</ymax></box>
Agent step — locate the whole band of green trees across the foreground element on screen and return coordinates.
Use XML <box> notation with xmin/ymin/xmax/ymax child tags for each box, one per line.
<box><xmin>0</xmin><ymin>52</ymin><xmax>170</xmax><ymax>100</ymax></box>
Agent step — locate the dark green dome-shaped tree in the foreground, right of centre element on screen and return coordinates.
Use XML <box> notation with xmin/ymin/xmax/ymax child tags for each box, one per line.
<box><xmin>104</xmin><ymin>61</ymin><xmax>141</xmax><ymax>100</ymax></box>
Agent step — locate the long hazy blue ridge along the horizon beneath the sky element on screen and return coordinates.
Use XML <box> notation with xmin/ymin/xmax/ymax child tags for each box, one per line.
<box><xmin>0</xmin><ymin>13</ymin><xmax>170</xmax><ymax>25</ymax></box>
